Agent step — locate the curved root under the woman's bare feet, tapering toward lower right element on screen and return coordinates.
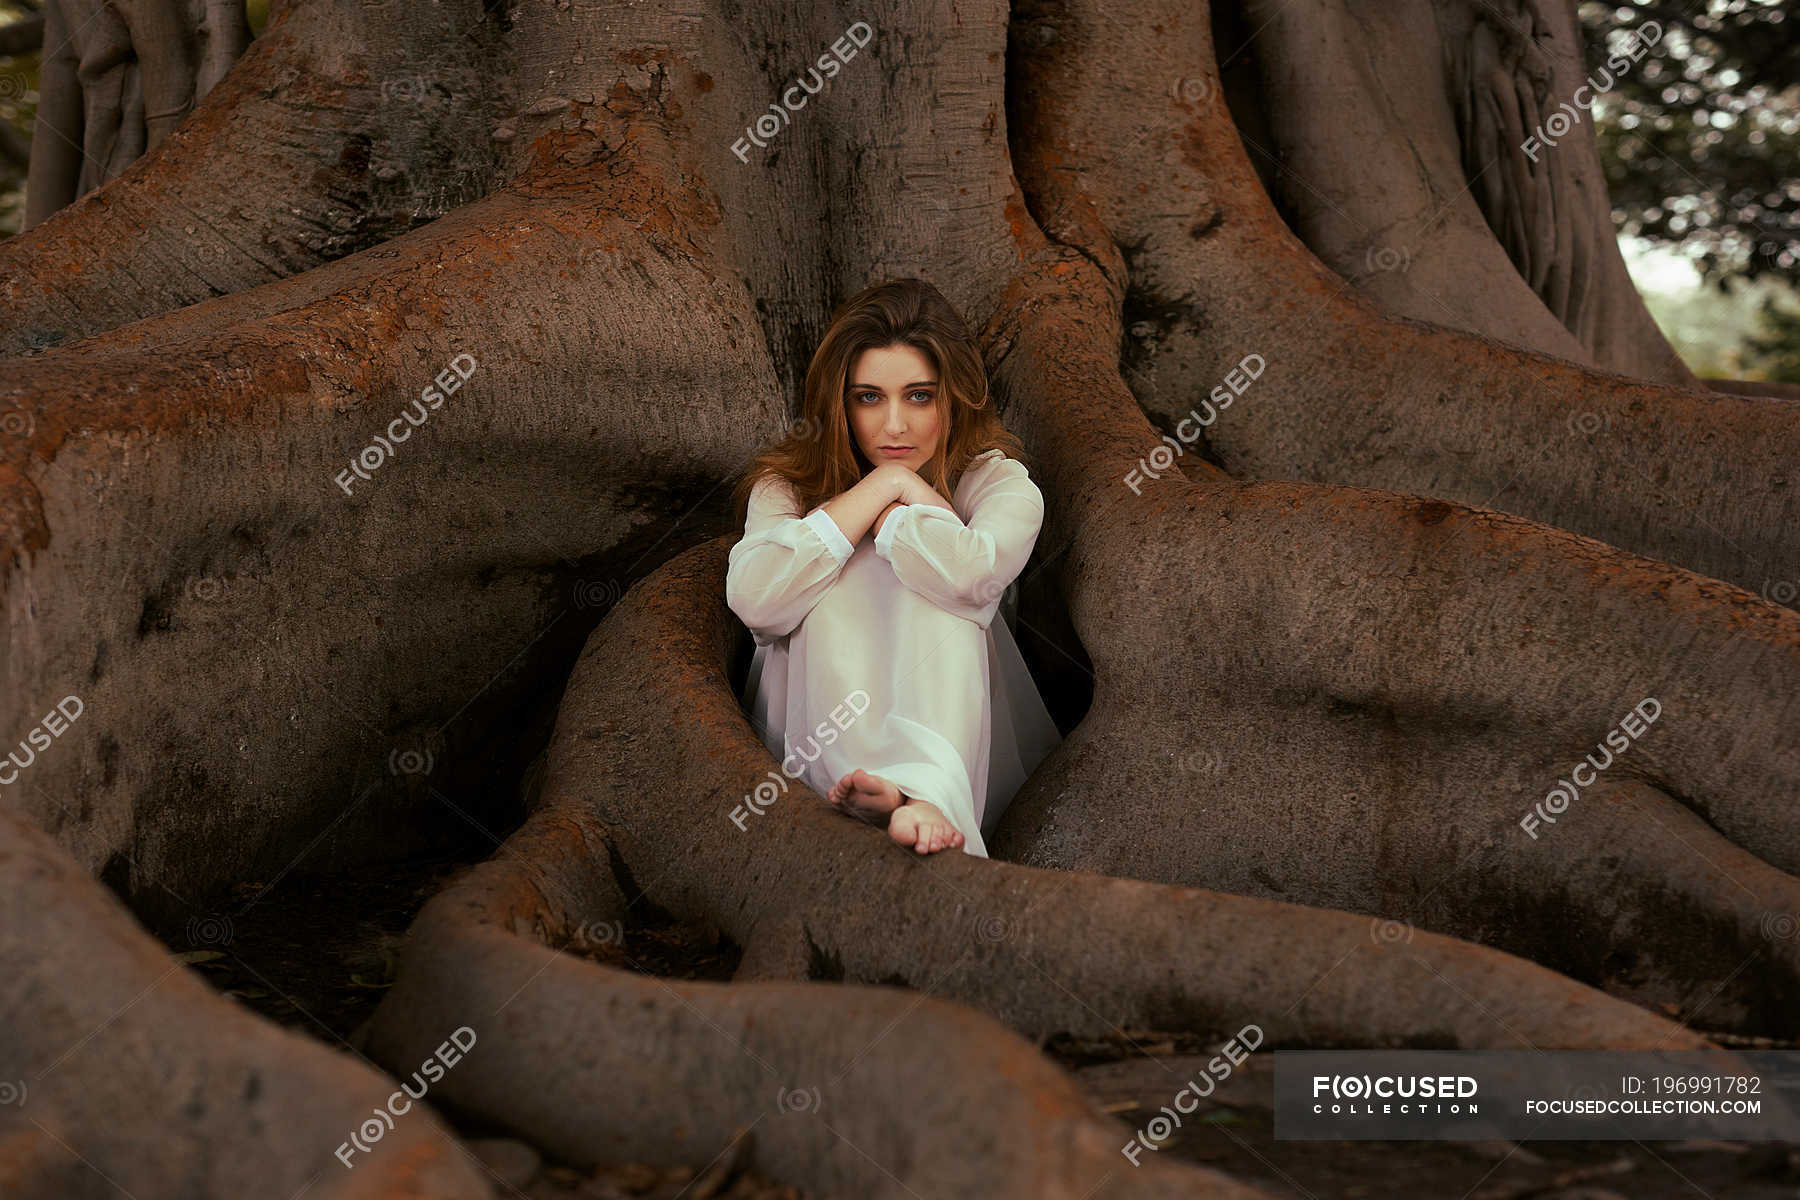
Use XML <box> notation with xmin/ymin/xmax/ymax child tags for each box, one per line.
<box><xmin>475</xmin><ymin>510</ymin><xmax>1701</xmax><ymax>1047</ymax></box>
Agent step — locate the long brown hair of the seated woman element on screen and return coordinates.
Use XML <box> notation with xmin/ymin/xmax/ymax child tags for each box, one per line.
<box><xmin>733</xmin><ymin>279</ymin><xmax>1024</xmax><ymax>525</ymax></box>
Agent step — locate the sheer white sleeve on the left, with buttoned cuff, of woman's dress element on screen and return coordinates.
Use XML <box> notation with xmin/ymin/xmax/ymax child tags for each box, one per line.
<box><xmin>725</xmin><ymin>475</ymin><xmax>855</xmax><ymax>646</ymax></box>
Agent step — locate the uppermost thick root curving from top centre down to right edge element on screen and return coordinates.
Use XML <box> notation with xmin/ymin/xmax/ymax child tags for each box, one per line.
<box><xmin>1012</xmin><ymin>0</ymin><xmax>1800</xmax><ymax>604</ymax></box>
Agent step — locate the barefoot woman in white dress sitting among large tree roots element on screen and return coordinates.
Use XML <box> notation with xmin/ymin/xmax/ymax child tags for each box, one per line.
<box><xmin>725</xmin><ymin>279</ymin><xmax>1058</xmax><ymax>858</ymax></box>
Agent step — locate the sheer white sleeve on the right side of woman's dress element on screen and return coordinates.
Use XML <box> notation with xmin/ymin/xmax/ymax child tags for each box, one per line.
<box><xmin>875</xmin><ymin>453</ymin><xmax>1044</xmax><ymax>630</ymax></box>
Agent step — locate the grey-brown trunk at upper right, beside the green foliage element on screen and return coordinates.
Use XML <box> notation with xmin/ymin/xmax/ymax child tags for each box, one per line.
<box><xmin>1219</xmin><ymin>0</ymin><xmax>1696</xmax><ymax>387</ymax></box>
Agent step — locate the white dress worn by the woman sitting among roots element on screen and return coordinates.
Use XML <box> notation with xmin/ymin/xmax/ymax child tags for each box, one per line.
<box><xmin>725</xmin><ymin>450</ymin><xmax>1060</xmax><ymax>858</ymax></box>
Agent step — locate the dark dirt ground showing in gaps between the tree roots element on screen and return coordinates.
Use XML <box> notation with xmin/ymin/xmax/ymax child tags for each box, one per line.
<box><xmin>157</xmin><ymin>860</ymin><xmax>1800</xmax><ymax>1200</ymax></box>
